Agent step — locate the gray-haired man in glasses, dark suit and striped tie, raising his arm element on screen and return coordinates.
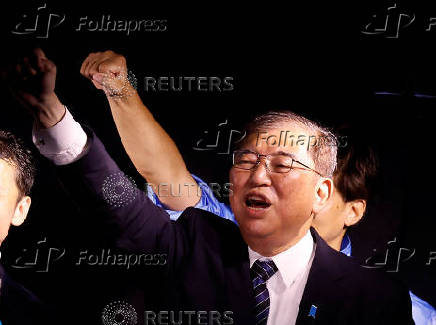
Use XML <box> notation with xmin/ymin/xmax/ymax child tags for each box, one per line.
<box><xmin>12</xmin><ymin>48</ymin><xmax>413</xmax><ymax>325</ymax></box>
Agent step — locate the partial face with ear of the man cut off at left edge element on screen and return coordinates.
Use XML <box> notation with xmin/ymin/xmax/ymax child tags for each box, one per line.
<box><xmin>0</xmin><ymin>159</ymin><xmax>30</xmax><ymax>245</ymax></box>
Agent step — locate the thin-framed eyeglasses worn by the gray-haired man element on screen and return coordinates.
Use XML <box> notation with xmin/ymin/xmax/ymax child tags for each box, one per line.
<box><xmin>233</xmin><ymin>150</ymin><xmax>322</xmax><ymax>176</ymax></box>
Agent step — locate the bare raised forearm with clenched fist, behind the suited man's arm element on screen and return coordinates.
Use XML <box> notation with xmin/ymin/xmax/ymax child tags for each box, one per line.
<box><xmin>80</xmin><ymin>51</ymin><xmax>200</xmax><ymax>210</ymax></box>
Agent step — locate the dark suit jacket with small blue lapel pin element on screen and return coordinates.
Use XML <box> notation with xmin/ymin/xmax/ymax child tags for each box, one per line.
<box><xmin>53</xmin><ymin>128</ymin><xmax>413</xmax><ymax>324</ymax></box>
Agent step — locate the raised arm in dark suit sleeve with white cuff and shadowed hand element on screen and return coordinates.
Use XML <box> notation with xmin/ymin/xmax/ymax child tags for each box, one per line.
<box><xmin>5</xmin><ymin>49</ymin><xmax>185</xmax><ymax>252</ymax></box>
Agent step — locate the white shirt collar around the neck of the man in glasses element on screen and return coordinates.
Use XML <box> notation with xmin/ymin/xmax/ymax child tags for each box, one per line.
<box><xmin>248</xmin><ymin>230</ymin><xmax>315</xmax><ymax>286</ymax></box>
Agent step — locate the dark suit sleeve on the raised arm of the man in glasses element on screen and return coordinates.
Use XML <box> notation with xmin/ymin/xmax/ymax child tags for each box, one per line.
<box><xmin>58</xmin><ymin>130</ymin><xmax>184</xmax><ymax>255</ymax></box>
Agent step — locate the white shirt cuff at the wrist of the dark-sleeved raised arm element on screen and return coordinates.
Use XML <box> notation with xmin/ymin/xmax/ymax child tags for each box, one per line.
<box><xmin>32</xmin><ymin>107</ymin><xmax>88</xmax><ymax>165</ymax></box>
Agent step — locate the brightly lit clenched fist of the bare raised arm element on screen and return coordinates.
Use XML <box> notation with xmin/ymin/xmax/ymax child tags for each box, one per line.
<box><xmin>80</xmin><ymin>51</ymin><xmax>136</xmax><ymax>99</ymax></box>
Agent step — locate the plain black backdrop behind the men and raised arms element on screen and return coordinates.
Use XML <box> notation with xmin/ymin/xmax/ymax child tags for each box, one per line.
<box><xmin>0</xmin><ymin>1</ymin><xmax>436</xmax><ymax>322</ymax></box>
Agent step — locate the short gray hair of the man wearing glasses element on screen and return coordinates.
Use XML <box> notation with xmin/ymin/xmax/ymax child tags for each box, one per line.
<box><xmin>245</xmin><ymin>111</ymin><xmax>338</xmax><ymax>177</ymax></box>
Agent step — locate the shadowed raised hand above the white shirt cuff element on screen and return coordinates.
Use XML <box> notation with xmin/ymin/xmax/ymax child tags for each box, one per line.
<box><xmin>3</xmin><ymin>48</ymin><xmax>65</xmax><ymax>128</ymax></box>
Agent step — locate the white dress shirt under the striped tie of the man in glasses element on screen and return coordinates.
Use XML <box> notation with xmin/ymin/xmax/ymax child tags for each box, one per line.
<box><xmin>248</xmin><ymin>231</ymin><xmax>315</xmax><ymax>325</ymax></box>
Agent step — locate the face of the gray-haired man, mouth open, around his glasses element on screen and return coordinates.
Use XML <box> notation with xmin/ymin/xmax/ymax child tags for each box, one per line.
<box><xmin>230</xmin><ymin>124</ymin><xmax>321</xmax><ymax>245</ymax></box>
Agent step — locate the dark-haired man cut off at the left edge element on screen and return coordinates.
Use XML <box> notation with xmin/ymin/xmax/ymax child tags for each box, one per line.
<box><xmin>0</xmin><ymin>130</ymin><xmax>52</xmax><ymax>325</ymax></box>
